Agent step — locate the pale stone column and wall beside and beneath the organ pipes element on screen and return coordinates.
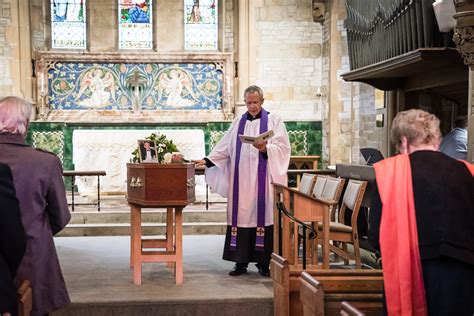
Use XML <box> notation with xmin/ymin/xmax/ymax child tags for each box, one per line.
<box><xmin>321</xmin><ymin>0</ymin><xmax>384</xmax><ymax>165</ymax></box>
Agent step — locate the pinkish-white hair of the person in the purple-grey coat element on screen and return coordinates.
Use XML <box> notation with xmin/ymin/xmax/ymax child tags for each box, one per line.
<box><xmin>0</xmin><ymin>96</ymin><xmax>32</xmax><ymax>135</ymax></box>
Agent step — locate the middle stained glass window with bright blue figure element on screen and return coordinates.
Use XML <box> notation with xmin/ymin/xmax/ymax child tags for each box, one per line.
<box><xmin>118</xmin><ymin>0</ymin><xmax>153</xmax><ymax>49</ymax></box>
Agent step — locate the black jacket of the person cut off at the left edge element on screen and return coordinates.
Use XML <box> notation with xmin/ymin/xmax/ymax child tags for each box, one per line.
<box><xmin>0</xmin><ymin>163</ymin><xmax>26</xmax><ymax>315</ymax></box>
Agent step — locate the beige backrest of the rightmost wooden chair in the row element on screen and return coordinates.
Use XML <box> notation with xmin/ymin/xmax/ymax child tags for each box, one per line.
<box><xmin>339</xmin><ymin>179</ymin><xmax>367</xmax><ymax>225</ymax></box>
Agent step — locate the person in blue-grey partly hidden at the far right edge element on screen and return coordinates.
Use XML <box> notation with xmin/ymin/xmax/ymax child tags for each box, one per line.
<box><xmin>439</xmin><ymin>116</ymin><xmax>467</xmax><ymax>160</ymax></box>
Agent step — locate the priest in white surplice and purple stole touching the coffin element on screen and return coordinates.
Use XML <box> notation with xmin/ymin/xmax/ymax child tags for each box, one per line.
<box><xmin>195</xmin><ymin>86</ymin><xmax>290</xmax><ymax>276</ymax></box>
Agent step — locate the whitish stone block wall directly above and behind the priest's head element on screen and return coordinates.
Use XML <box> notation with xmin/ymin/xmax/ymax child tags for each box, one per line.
<box><xmin>249</xmin><ymin>0</ymin><xmax>323</xmax><ymax>120</ymax></box>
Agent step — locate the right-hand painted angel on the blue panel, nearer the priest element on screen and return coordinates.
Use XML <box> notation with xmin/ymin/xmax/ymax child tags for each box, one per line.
<box><xmin>158</xmin><ymin>69</ymin><xmax>198</xmax><ymax>108</ymax></box>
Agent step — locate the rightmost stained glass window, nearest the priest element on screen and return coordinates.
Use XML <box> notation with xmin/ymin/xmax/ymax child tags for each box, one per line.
<box><xmin>184</xmin><ymin>0</ymin><xmax>218</xmax><ymax>50</ymax></box>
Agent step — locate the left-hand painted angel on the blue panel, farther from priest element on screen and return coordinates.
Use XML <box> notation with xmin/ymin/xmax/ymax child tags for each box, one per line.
<box><xmin>76</xmin><ymin>68</ymin><xmax>115</xmax><ymax>108</ymax></box>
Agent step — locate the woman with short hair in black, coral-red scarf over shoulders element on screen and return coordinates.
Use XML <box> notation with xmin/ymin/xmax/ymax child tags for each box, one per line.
<box><xmin>369</xmin><ymin>109</ymin><xmax>474</xmax><ymax>315</ymax></box>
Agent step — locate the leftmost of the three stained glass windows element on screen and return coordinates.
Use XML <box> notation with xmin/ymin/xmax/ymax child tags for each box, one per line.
<box><xmin>51</xmin><ymin>0</ymin><xmax>86</xmax><ymax>49</ymax></box>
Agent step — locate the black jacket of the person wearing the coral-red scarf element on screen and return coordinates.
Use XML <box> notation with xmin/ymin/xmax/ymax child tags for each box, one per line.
<box><xmin>369</xmin><ymin>151</ymin><xmax>474</xmax><ymax>265</ymax></box>
